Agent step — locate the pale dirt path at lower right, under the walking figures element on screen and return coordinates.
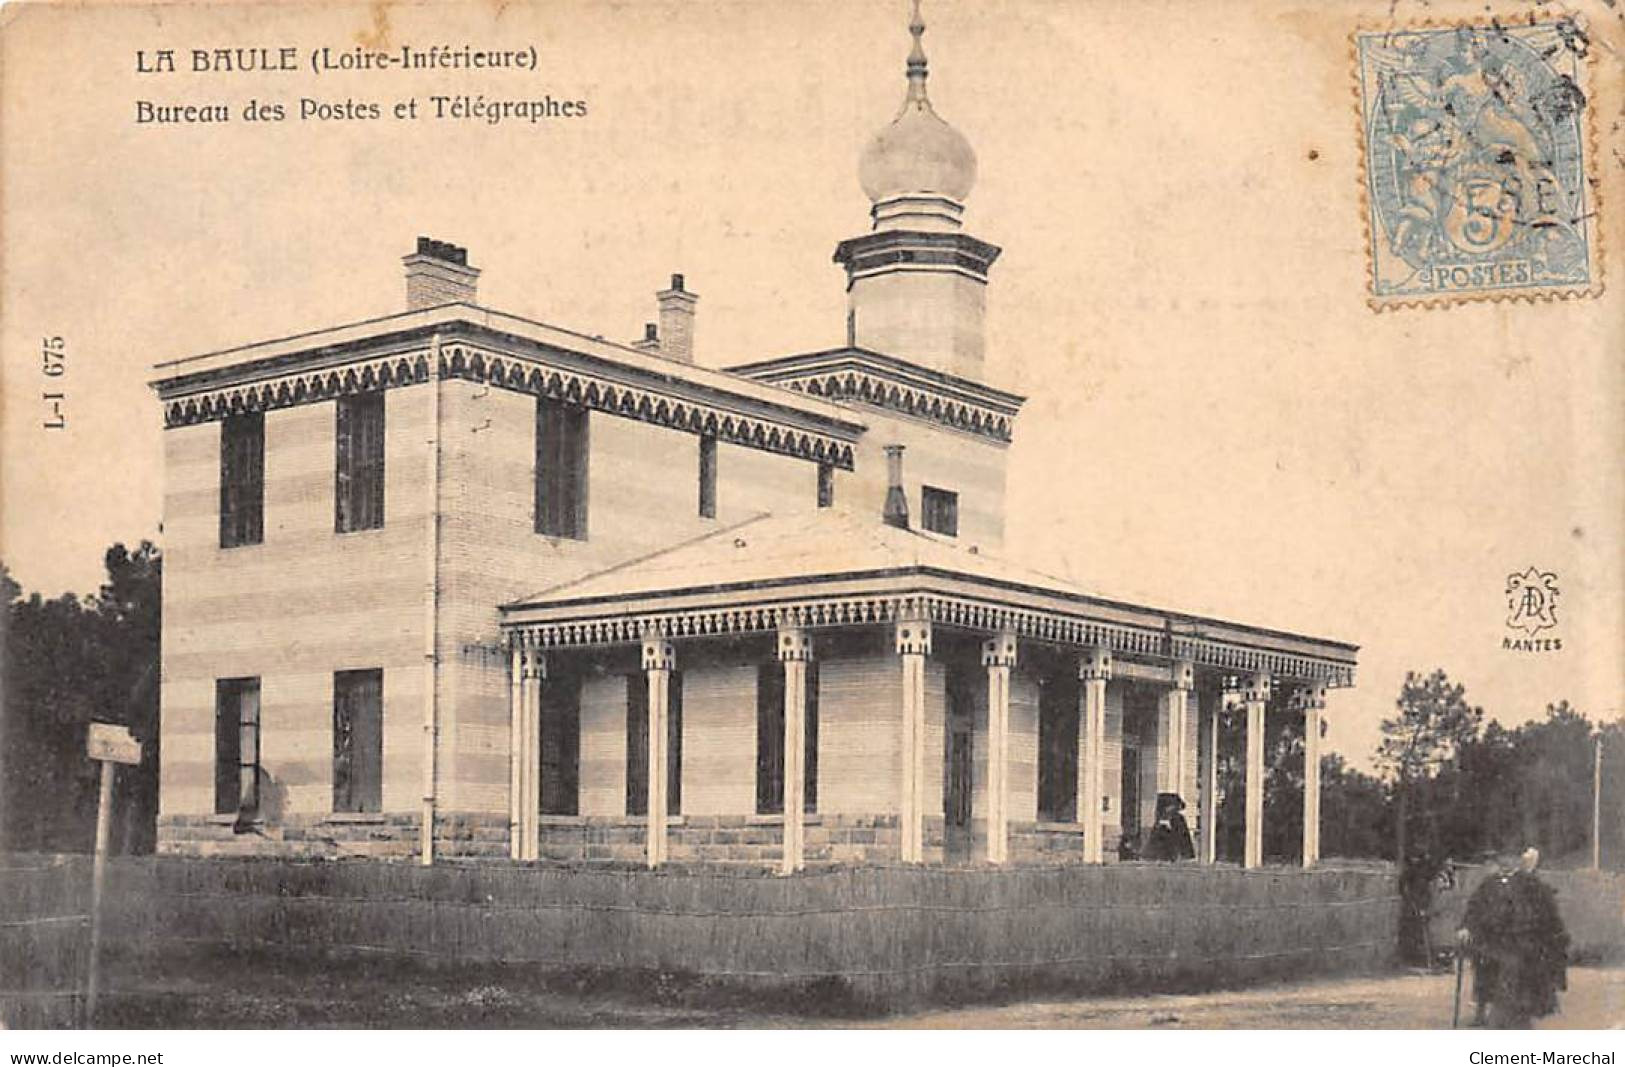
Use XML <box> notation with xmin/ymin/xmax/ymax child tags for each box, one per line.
<box><xmin>861</xmin><ymin>968</ymin><xmax>1625</xmax><ymax>1030</ymax></box>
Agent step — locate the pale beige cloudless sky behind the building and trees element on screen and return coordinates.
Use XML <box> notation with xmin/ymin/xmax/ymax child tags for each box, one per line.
<box><xmin>0</xmin><ymin>0</ymin><xmax>1625</xmax><ymax>765</ymax></box>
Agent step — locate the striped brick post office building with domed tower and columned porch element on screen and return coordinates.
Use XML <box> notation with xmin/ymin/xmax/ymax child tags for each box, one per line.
<box><xmin>154</xmin><ymin>15</ymin><xmax>1355</xmax><ymax>872</ymax></box>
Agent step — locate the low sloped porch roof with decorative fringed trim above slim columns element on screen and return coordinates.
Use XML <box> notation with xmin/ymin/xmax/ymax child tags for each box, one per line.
<box><xmin>502</xmin><ymin>508</ymin><xmax>1355</xmax><ymax>684</ymax></box>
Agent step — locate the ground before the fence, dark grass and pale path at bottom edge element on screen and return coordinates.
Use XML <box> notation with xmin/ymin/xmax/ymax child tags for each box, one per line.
<box><xmin>85</xmin><ymin>953</ymin><xmax>1625</xmax><ymax>1030</ymax></box>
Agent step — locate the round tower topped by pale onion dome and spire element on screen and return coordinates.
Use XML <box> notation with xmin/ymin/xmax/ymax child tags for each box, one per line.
<box><xmin>835</xmin><ymin>0</ymin><xmax>999</xmax><ymax>380</ymax></box>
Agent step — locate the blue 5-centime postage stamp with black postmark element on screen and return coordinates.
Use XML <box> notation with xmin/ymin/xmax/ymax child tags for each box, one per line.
<box><xmin>1355</xmin><ymin>18</ymin><xmax>1602</xmax><ymax>310</ymax></box>
